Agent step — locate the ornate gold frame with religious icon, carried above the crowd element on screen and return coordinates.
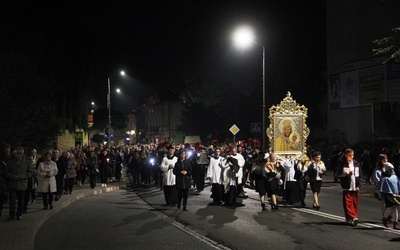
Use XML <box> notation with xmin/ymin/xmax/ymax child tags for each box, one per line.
<box><xmin>266</xmin><ymin>92</ymin><xmax>310</xmax><ymax>159</ymax></box>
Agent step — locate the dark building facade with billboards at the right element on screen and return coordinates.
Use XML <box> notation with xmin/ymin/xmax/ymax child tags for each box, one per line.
<box><xmin>327</xmin><ymin>0</ymin><xmax>400</xmax><ymax>144</ymax></box>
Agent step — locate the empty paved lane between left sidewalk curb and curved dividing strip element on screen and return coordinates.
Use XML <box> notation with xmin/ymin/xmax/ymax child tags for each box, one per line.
<box><xmin>35</xmin><ymin>190</ymin><xmax>223</xmax><ymax>250</ymax></box>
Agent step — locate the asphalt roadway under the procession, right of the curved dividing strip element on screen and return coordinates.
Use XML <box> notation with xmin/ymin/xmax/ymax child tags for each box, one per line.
<box><xmin>134</xmin><ymin>178</ymin><xmax>400</xmax><ymax>250</ymax></box>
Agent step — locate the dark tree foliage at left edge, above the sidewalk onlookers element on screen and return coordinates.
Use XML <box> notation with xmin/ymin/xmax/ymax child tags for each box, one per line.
<box><xmin>0</xmin><ymin>53</ymin><xmax>65</xmax><ymax>149</ymax></box>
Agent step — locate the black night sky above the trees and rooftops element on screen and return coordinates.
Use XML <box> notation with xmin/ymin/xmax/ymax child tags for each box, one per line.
<box><xmin>1</xmin><ymin>0</ymin><xmax>326</xmax><ymax>113</ymax></box>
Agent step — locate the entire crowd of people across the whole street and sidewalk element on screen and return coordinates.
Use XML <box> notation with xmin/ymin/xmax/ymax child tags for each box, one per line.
<box><xmin>0</xmin><ymin>143</ymin><xmax>400</xmax><ymax>229</ymax></box>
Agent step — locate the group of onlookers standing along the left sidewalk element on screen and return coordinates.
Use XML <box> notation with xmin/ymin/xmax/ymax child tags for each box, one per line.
<box><xmin>0</xmin><ymin>144</ymin><xmax>122</xmax><ymax>221</ymax></box>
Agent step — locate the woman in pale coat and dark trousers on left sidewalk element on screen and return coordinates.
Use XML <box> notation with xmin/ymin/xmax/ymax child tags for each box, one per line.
<box><xmin>37</xmin><ymin>152</ymin><xmax>58</xmax><ymax>210</ymax></box>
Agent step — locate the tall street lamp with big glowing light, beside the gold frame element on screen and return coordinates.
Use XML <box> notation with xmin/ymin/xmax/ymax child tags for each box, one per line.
<box><xmin>233</xmin><ymin>26</ymin><xmax>266</xmax><ymax>152</ymax></box>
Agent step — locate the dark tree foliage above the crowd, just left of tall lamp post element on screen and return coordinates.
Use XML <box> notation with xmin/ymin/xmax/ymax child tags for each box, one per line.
<box><xmin>176</xmin><ymin>74</ymin><xmax>262</xmax><ymax>141</ymax></box>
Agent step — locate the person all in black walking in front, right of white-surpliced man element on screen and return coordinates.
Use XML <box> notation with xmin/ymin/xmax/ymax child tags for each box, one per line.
<box><xmin>173</xmin><ymin>151</ymin><xmax>192</xmax><ymax>211</ymax></box>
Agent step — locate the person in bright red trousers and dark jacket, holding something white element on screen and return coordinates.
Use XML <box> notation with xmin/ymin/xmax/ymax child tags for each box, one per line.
<box><xmin>337</xmin><ymin>148</ymin><xmax>362</xmax><ymax>227</ymax></box>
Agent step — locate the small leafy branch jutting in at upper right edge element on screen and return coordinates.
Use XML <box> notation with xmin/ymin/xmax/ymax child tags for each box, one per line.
<box><xmin>373</xmin><ymin>27</ymin><xmax>400</xmax><ymax>63</ymax></box>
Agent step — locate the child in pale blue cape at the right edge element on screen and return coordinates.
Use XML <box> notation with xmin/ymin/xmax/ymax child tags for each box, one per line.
<box><xmin>379</xmin><ymin>162</ymin><xmax>400</xmax><ymax>230</ymax></box>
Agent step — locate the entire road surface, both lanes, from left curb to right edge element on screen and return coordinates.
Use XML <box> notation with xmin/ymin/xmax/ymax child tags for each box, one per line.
<box><xmin>35</xmin><ymin>170</ymin><xmax>400</xmax><ymax>250</ymax></box>
